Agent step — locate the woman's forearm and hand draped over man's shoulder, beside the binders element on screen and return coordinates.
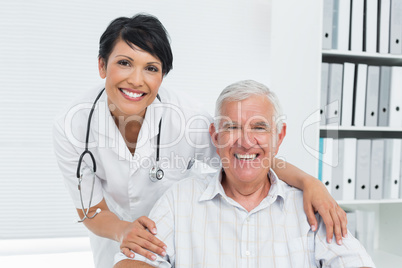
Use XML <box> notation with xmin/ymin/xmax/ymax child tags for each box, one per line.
<box><xmin>273</xmin><ymin>158</ymin><xmax>347</xmax><ymax>244</ymax></box>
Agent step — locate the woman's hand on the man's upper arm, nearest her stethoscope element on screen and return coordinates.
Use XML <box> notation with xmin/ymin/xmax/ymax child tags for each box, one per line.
<box><xmin>120</xmin><ymin>216</ymin><xmax>166</xmax><ymax>260</ymax></box>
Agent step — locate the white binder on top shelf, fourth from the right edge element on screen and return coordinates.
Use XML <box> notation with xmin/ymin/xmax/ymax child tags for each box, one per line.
<box><xmin>350</xmin><ymin>0</ymin><xmax>364</xmax><ymax>52</ymax></box>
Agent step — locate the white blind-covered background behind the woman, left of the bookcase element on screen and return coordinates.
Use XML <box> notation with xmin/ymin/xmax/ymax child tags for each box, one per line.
<box><xmin>0</xmin><ymin>0</ymin><xmax>279</xmax><ymax>239</ymax></box>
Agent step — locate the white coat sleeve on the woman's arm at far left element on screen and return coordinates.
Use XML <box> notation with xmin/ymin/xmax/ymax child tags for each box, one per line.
<box><xmin>53</xmin><ymin>116</ymin><xmax>103</xmax><ymax>209</ymax></box>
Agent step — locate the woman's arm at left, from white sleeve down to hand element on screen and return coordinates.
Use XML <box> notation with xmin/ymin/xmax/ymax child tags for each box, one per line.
<box><xmin>53</xmin><ymin>120</ymin><xmax>165</xmax><ymax>259</ymax></box>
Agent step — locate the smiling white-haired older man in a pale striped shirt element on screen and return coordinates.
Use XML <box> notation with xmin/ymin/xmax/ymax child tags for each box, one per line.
<box><xmin>115</xmin><ymin>80</ymin><xmax>374</xmax><ymax>268</ymax></box>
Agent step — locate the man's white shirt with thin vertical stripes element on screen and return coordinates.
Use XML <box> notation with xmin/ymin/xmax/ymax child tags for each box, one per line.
<box><xmin>115</xmin><ymin>170</ymin><xmax>375</xmax><ymax>268</ymax></box>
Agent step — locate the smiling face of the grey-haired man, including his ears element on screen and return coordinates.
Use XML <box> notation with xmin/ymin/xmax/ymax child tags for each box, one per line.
<box><xmin>210</xmin><ymin>96</ymin><xmax>286</xmax><ymax>183</ymax></box>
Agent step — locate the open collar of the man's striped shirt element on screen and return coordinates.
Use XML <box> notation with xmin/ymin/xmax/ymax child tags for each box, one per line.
<box><xmin>198</xmin><ymin>169</ymin><xmax>286</xmax><ymax>209</ymax></box>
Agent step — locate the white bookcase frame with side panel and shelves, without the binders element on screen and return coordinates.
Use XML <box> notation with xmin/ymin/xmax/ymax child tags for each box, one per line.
<box><xmin>270</xmin><ymin>0</ymin><xmax>402</xmax><ymax>268</ymax></box>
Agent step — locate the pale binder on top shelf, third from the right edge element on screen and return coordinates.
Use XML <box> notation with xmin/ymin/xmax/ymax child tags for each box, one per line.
<box><xmin>364</xmin><ymin>0</ymin><xmax>378</xmax><ymax>53</ymax></box>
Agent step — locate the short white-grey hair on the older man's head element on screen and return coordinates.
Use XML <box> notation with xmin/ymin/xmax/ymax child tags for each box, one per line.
<box><xmin>215</xmin><ymin>80</ymin><xmax>283</xmax><ymax>134</ymax></box>
